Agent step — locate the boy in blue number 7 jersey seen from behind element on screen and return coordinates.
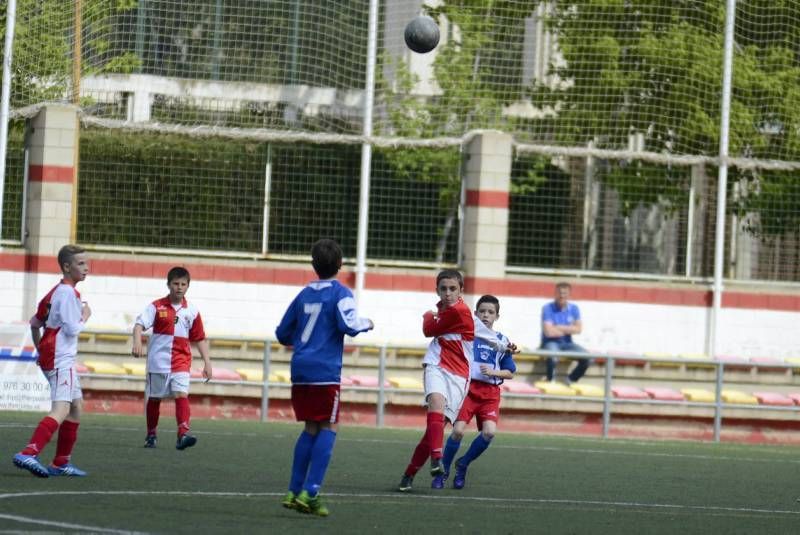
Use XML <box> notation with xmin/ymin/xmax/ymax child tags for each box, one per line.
<box><xmin>275</xmin><ymin>239</ymin><xmax>373</xmax><ymax>516</ymax></box>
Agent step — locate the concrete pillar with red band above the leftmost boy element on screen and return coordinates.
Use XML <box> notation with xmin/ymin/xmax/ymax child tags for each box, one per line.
<box><xmin>21</xmin><ymin>104</ymin><xmax>78</xmax><ymax>319</ymax></box>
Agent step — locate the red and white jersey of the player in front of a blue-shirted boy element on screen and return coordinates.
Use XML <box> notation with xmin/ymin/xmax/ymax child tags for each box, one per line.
<box><xmin>422</xmin><ymin>299</ymin><xmax>508</xmax><ymax>378</ymax></box>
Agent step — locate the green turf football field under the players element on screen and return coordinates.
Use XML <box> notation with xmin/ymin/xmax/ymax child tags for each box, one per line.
<box><xmin>0</xmin><ymin>412</ymin><xmax>800</xmax><ymax>535</ymax></box>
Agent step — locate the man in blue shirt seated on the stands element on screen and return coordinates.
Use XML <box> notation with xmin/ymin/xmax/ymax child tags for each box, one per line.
<box><xmin>541</xmin><ymin>282</ymin><xmax>591</xmax><ymax>384</ymax></box>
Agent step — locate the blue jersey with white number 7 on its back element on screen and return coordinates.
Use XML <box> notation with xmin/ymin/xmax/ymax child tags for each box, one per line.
<box><xmin>275</xmin><ymin>279</ymin><xmax>371</xmax><ymax>385</ymax></box>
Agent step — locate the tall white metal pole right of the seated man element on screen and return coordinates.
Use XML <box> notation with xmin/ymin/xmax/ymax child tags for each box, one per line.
<box><xmin>707</xmin><ymin>0</ymin><xmax>736</xmax><ymax>358</ymax></box>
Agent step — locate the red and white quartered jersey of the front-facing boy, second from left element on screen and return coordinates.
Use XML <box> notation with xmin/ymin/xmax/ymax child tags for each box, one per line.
<box><xmin>136</xmin><ymin>296</ymin><xmax>206</xmax><ymax>373</ymax></box>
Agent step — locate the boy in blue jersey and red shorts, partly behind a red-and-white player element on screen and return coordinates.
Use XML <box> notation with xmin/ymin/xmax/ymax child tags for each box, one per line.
<box><xmin>431</xmin><ymin>295</ymin><xmax>517</xmax><ymax>489</ymax></box>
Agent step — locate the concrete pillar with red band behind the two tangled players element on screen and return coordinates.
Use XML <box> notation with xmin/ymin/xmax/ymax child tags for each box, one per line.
<box><xmin>463</xmin><ymin>131</ymin><xmax>512</xmax><ymax>278</ymax></box>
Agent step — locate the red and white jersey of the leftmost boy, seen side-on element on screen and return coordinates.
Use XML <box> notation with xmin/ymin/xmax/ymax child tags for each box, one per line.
<box><xmin>30</xmin><ymin>280</ymin><xmax>85</xmax><ymax>371</ymax></box>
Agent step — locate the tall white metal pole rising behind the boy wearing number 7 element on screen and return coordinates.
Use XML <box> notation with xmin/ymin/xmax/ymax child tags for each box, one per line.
<box><xmin>355</xmin><ymin>0</ymin><xmax>378</xmax><ymax>304</ymax></box>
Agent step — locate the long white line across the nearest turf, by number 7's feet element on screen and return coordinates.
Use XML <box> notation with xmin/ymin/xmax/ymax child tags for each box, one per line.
<box><xmin>0</xmin><ymin>490</ymin><xmax>800</xmax><ymax>516</ymax></box>
